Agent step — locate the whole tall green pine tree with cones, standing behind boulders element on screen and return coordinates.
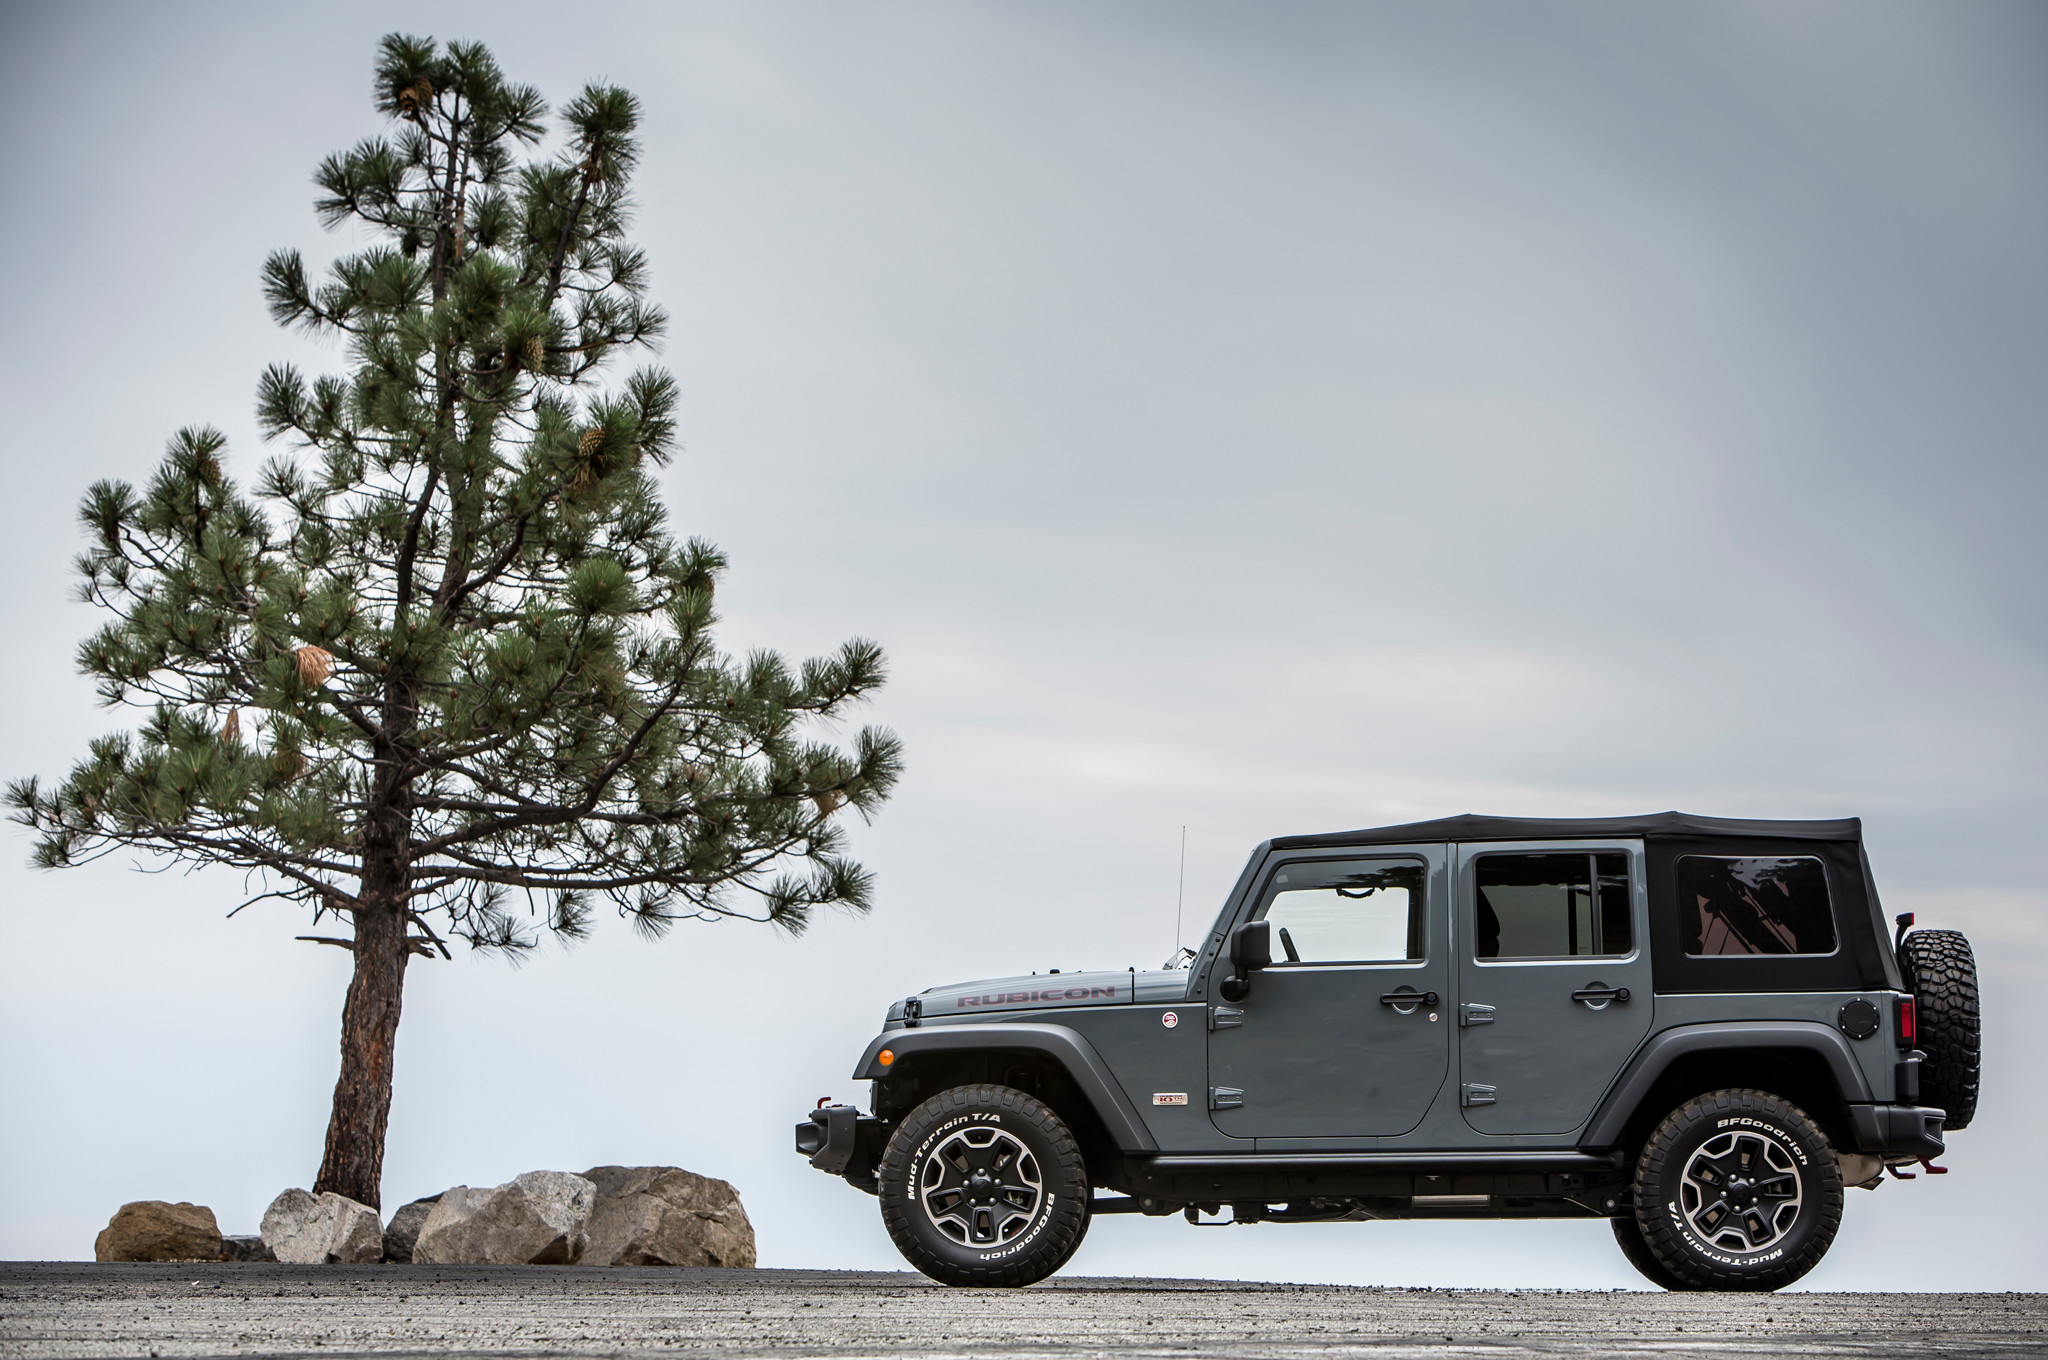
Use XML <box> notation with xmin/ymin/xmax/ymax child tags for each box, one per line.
<box><xmin>8</xmin><ymin>35</ymin><xmax>899</xmax><ymax>1206</ymax></box>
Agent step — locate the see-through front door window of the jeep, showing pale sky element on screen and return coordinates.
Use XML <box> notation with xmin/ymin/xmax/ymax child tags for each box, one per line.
<box><xmin>1262</xmin><ymin>860</ymin><xmax>1427</xmax><ymax>967</ymax></box>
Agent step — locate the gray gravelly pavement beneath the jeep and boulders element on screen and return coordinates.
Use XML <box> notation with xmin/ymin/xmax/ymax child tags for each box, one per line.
<box><xmin>0</xmin><ymin>1264</ymin><xmax>2048</xmax><ymax>1360</ymax></box>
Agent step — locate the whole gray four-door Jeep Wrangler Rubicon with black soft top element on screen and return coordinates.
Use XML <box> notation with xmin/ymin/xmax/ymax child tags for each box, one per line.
<box><xmin>797</xmin><ymin>813</ymin><xmax>1978</xmax><ymax>1290</ymax></box>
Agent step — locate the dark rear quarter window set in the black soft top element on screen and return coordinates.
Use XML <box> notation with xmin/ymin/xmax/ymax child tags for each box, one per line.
<box><xmin>1677</xmin><ymin>854</ymin><xmax>1835</xmax><ymax>959</ymax></box>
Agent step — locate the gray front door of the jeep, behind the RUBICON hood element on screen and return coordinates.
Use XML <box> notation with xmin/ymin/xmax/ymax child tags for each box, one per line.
<box><xmin>1208</xmin><ymin>846</ymin><xmax>1452</xmax><ymax>1139</ymax></box>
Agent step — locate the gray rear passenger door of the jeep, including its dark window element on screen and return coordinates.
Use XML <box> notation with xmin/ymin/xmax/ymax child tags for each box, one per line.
<box><xmin>1456</xmin><ymin>842</ymin><xmax>1651</xmax><ymax>1133</ymax></box>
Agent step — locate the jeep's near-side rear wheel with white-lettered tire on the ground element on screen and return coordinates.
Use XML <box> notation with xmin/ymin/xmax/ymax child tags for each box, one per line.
<box><xmin>1616</xmin><ymin>1090</ymin><xmax>1841</xmax><ymax>1290</ymax></box>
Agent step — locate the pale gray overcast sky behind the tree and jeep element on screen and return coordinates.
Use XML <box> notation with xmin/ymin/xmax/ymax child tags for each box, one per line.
<box><xmin>0</xmin><ymin>0</ymin><xmax>2048</xmax><ymax>1288</ymax></box>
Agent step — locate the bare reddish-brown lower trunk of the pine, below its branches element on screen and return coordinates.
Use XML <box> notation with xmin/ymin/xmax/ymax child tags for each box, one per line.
<box><xmin>313</xmin><ymin>903</ymin><xmax>408</xmax><ymax>1208</ymax></box>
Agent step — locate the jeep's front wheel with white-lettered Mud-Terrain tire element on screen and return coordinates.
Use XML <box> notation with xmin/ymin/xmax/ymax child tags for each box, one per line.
<box><xmin>877</xmin><ymin>1083</ymin><xmax>1090</xmax><ymax>1288</ymax></box>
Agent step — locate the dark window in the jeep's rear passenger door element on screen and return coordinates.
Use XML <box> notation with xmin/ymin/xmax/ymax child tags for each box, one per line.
<box><xmin>1475</xmin><ymin>850</ymin><xmax>1634</xmax><ymax>959</ymax></box>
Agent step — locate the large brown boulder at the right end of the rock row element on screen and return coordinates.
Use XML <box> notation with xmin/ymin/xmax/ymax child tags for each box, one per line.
<box><xmin>584</xmin><ymin>1165</ymin><xmax>754</xmax><ymax>1270</ymax></box>
